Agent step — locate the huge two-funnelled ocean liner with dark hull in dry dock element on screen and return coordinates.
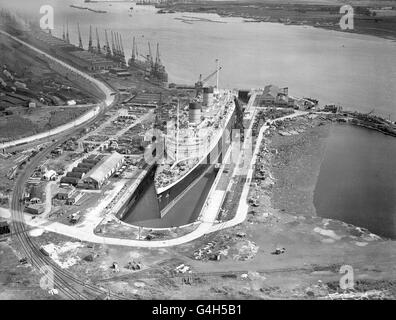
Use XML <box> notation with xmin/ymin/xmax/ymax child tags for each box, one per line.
<box><xmin>154</xmin><ymin>87</ymin><xmax>240</xmax><ymax>216</ymax></box>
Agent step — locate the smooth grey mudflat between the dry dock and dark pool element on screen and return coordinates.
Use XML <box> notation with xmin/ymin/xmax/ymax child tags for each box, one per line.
<box><xmin>268</xmin><ymin>116</ymin><xmax>333</xmax><ymax>216</ymax></box>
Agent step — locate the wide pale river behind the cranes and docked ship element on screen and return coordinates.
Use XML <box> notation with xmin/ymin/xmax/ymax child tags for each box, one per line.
<box><xmin>0</xmin><ymin>0</ymin><xmax>396</xmax><ymax>120</ymax></box>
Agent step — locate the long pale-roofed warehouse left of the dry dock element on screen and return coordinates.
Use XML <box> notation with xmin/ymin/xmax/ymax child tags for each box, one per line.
<box><xmin>78</xmin><ymin>152</ymin><xmax>124</xmax><ymax>189</ymax></box>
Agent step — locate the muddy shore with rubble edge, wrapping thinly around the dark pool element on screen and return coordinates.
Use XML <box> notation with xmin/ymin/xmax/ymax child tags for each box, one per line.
<box><xmin>254</xmin><ymin>114</ymin><xmax>395</xmax><ymax>241</ymax></box>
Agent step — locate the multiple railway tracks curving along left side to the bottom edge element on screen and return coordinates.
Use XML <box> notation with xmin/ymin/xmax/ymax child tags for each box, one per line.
<box><xmin>11</xmin><ymin>96</ymin><xmax>125</xmax><ymax>300</ymax></box>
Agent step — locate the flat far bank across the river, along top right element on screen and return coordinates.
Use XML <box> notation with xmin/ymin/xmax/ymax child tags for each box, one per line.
<box><xmin>169</xmin><ymin>0</ymin><xmax>396</xmax><ymax>40</ymax></box>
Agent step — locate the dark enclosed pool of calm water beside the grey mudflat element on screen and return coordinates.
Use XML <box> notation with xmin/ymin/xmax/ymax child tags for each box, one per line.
<box><xmin>314</xmin><ymin>125</ymin><xmax>396</xmax><ymax>238</ymax></box>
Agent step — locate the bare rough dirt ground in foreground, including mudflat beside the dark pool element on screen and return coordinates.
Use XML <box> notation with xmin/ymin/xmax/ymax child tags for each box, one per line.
<box><xmin>1</xmin><ymin>114</ymin><xmax>396</xmax><ymax>299</ymax></box>
